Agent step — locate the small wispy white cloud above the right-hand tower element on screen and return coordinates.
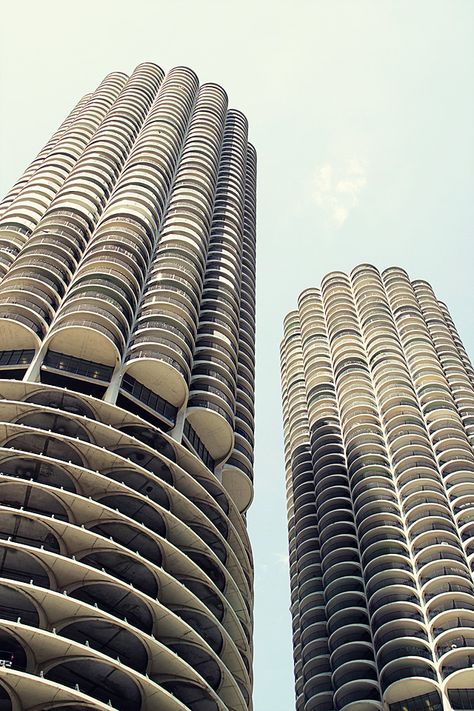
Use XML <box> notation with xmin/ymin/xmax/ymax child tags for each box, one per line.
<box><xmin>311</xmin><ymin>158</ymin><xmax>367</xmax><ymax>229</ymax></box>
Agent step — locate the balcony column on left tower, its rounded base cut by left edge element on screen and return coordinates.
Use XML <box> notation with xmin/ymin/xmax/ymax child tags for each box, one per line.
<box><xmin>0</xmin><ymin>65</ymin><xmax>161</xmax><ymax>348</ymax></box>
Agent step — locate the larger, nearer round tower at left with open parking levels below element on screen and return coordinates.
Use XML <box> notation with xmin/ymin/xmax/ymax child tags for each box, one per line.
<box><xmin>0</xmin><ymin>63</ymin><xmax>256</xmax><ymax>711</ymax></box>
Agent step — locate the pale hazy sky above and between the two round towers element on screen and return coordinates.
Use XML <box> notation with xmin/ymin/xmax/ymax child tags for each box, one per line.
<box><xmin>0</xmin><ymin>0</ymin><xmax>474</xmax><ymax>711</ymax></box>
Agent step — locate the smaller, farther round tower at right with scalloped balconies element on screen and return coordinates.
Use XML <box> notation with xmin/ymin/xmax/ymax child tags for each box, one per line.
<box><xmin>281</xmin><ymin>264</ymin><xmax>474</xmax><ymax>711</ymax></box>
